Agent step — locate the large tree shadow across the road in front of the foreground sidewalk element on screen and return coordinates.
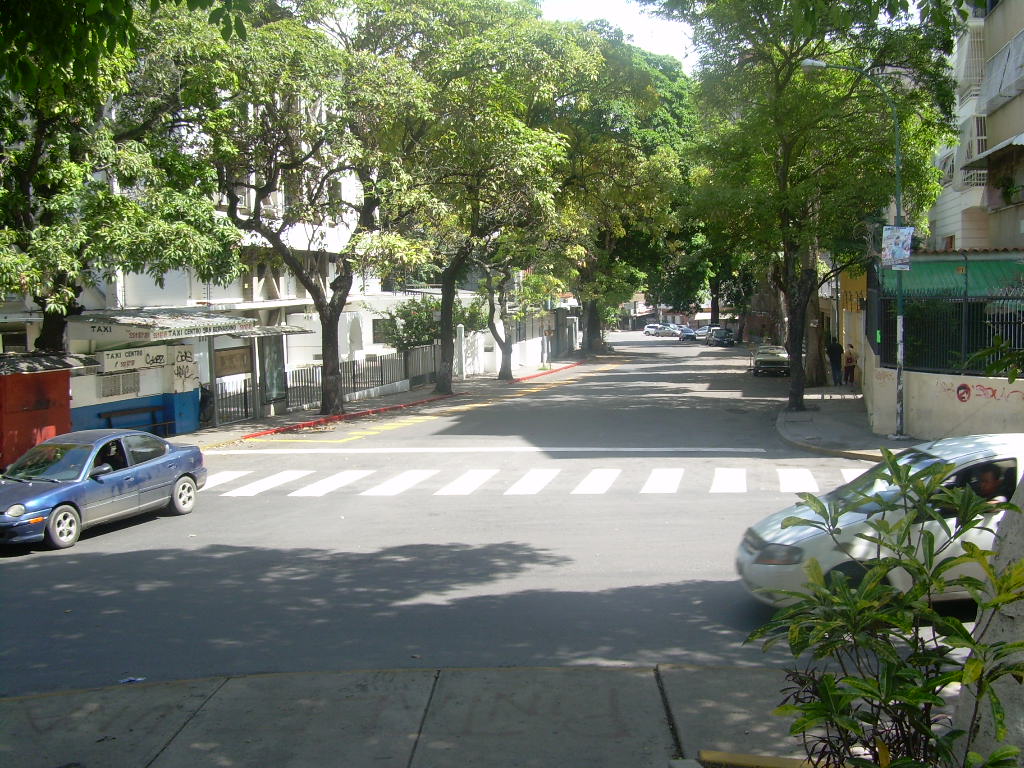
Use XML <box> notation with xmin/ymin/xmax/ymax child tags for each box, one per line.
<box><xmin>2</xmin><ymin>542</ymin><xmax>783</xmax><ymax>695</ymax></box>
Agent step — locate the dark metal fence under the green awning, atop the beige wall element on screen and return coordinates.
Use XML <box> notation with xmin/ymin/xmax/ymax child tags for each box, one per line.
<box><xmin>879</xmin><ymin>293</ymin><xmax>1024</xmax><ymax>374</ymax></box>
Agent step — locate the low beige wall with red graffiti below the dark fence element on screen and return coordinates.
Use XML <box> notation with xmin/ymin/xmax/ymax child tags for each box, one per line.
<box><xmin>861</xmin><ymin>352</ymin><xmax>1024</xmax><ymax>440</ymax></box>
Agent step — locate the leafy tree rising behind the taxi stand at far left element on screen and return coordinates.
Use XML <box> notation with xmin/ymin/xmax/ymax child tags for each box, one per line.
<box><xmin>0</xmin><ymin>7</ymin><xmax>238</xmax><ymax>350</ymax></box>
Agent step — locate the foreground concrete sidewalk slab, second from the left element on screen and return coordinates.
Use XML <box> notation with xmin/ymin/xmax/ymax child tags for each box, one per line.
<box><xmin>153</xmin><ymin>670</ymin><xmax>436</xmax><ymax>768</ymax></box>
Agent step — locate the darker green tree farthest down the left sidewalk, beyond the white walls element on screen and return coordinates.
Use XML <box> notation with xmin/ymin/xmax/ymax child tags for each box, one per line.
<box><xmin>551</xmin><ymin>34</ymin><xmax>687</xmax><ymax>350</ymax></box>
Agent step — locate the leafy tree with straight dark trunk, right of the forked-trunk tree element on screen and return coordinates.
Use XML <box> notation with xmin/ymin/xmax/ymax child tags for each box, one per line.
<box><xmin>399</xmin><ymin>0</ymin><xmax>589</xmax><ymax>392</ymax></box>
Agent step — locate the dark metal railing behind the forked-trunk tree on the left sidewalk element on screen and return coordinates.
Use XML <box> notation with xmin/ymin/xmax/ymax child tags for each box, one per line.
<box><xmin>288</xmin><ymin>346</ymin><xmax>437</xmax><ymax>411</ymax></box>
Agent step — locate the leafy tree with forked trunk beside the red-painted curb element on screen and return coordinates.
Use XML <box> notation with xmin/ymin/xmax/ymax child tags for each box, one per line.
<box><xmin>197</xmin><ymin>2</ymin><xmax>427</xmax><ymax>414</ymax></box>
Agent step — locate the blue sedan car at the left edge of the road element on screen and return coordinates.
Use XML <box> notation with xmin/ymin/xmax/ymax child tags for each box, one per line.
<box><xmin>0</xmin><ymin>429</ymin><xmax>207</xmax><ymax>549</ymax></box>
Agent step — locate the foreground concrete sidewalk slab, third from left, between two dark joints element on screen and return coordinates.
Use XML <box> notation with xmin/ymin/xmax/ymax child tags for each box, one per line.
<box><xmin>411</xmin><ymin>667</ymin><xmax>675</xmax><ymax>768</ymax></box>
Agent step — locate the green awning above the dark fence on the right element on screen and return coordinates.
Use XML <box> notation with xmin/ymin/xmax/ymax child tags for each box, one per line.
<box><xmin>881</xmin><ymin>259</ymin><xmax>1024</xmax><ymax>298</ymax></box>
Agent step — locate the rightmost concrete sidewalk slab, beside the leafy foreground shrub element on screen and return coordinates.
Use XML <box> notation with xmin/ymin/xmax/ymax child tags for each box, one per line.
<box><xmin>658</xmin><ymin>666</ymin><xmax>807</xmax><ymax>759</ymax></box>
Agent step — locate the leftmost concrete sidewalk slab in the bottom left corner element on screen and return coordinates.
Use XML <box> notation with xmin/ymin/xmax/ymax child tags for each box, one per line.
<box><xmin>0</xmin><ymin>678</ymin><xmax>224</xmax><ymax>768</ymax></box>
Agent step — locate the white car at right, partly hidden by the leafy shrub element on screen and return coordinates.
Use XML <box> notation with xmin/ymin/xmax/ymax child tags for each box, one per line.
<box><xmin>735</xmin><ymin>433</ymin><xmax>1024</xmax><ymax>605</ymax></box>
